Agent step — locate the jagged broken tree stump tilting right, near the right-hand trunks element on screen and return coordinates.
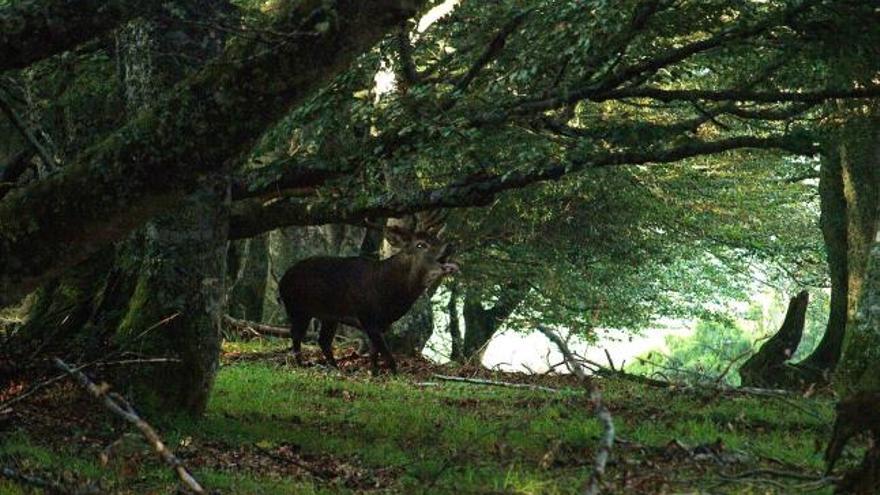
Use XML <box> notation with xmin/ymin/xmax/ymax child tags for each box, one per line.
<box><xmin>739</xmin><ymin>291</ymin><xmax>810</xmax><ymax>387</ymax></box>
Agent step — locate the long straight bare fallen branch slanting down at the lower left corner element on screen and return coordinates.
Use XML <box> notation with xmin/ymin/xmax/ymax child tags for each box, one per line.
<box><xmin>54</xmin><ymin>358</ymin><xmax>206</xmax><ymax>493</ymax></box>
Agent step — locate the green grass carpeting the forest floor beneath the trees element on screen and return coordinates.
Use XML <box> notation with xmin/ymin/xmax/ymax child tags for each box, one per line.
<box><xmin>0</xmin><ymin>344</ymin><xmax>832</xmax><ymax>494</ymax></box>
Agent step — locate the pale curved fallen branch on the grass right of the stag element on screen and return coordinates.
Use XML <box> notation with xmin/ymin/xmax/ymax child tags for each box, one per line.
<box><xmin>538</xmin><ymin>325</ymin><xmax>614</xmax><ymax>495</ymax></box>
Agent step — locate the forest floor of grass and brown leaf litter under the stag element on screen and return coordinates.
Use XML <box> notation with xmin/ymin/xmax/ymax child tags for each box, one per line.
<box><xmin>0</xmin><ymin>339</ymin><xmax>857</xmax><ymax>494</ymax></box>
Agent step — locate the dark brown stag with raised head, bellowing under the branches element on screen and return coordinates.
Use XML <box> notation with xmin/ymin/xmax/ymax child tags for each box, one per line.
<box><xmin>279</xmin><ymin>212</ymin><xmax>459</xmax><ymax>375</ymax></box>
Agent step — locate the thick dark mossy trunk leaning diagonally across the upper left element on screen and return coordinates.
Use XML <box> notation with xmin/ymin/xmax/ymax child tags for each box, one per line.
<box><xmin>0</xmin><ymin>0</ymin><xmax>420</xmax><ymax>305</ymax></box>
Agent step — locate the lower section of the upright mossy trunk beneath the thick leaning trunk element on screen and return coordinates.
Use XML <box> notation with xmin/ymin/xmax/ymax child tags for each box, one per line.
<box><xmin>113</xmin><ymin>178</ymin><xmax>229</xmax><ymax>415</ymax></box>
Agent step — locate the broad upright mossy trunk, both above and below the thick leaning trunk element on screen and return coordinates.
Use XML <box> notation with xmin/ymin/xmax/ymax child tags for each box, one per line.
<box><xmin>3</xmin><ymin>10</ymin><xmax>235</xmax><ymax>415</ymax></box>
